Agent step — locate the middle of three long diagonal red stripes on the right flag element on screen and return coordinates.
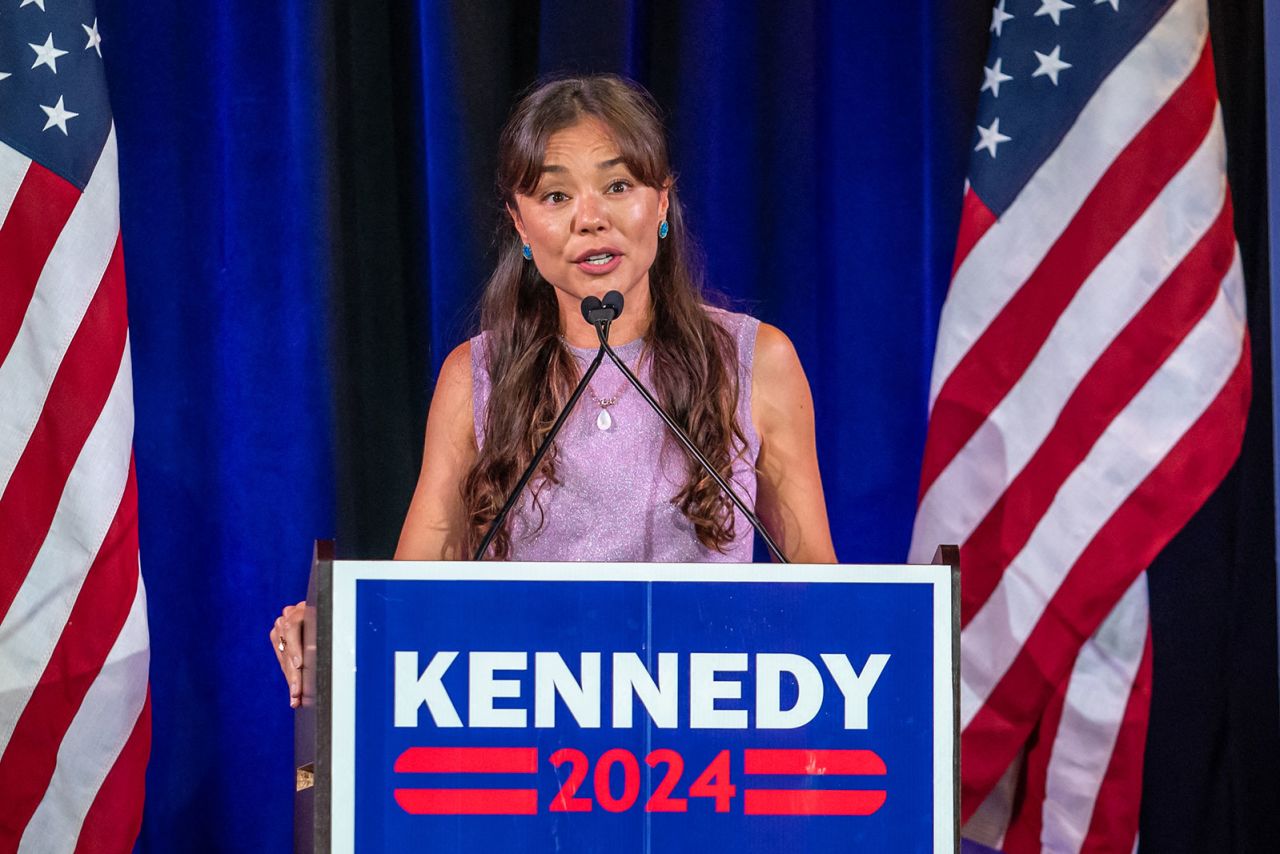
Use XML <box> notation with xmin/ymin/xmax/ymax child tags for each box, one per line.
<box><xmin>960</xmin><ymin>196</ymin><xmax>1235</xmax><ymax>626</ymax></box>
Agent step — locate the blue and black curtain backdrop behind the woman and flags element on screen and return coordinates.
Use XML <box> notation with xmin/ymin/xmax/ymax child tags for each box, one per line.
<box><xmin>87</xmin><ymin>0</ymin><xmax>1280</xmax><ymax>851</ymax></box>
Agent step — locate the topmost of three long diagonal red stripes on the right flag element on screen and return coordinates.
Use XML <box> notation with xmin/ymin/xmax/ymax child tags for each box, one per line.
<box><xmin>920</xmin><ymin>42</ymin><xmax>1217</xmax><ymax>497</ymax></box>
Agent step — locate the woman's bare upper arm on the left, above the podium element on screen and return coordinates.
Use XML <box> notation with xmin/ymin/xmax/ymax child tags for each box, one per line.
<box><xmin>396</xmin><ymin>342</ymin><xmax>476</xmax><ymax>561</ymax></box>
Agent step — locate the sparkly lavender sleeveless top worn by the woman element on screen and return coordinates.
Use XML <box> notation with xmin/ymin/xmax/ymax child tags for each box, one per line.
<box><xmin>471</xmin><ymin>309</ymin><xmax>760</xmax><ymax>563</ymax></box>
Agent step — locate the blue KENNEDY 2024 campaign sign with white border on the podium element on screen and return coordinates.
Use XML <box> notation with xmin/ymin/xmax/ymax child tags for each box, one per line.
<box><xmin>332</xmin><ymin>562</ymin><xmax>955</xmax><ymax>854</ymax></box>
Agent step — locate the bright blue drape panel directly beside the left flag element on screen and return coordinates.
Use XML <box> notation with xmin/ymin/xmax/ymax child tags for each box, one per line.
<box><xmin>99</xmin><ymin>0</ymin><xmax>334</xmax><ymax>851</ymax></box>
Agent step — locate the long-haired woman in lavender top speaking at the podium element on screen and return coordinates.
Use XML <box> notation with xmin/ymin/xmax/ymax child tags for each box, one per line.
<box><xmin>270</xmin><ymin>76</ymin><xmax>836</xmax><ymax>705</ymax></box>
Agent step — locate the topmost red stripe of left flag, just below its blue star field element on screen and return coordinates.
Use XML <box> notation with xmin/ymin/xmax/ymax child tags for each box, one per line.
<box><xmin>0</xmin><ymin>161</ymin><xmax>81</xmax><ymax>362</ymax></box>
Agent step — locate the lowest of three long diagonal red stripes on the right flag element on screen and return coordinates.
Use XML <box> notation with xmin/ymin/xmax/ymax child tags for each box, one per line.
<box><xmin>961</xmin><ymin>337</ymin><xmax>1251</xmax><ymax>819</ymax></box>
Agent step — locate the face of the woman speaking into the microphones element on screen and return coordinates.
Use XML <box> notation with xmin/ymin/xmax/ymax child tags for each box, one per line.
<box><xmin>509</xmin><ymin>119</ymin><xmax>667</xmax><ymax>332</ymax></box>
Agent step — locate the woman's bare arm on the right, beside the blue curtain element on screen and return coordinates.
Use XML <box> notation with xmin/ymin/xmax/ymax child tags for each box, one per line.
<box><xmin>751</xmin><ymin>323</ymin><xmax>836</xmax><ymax>563</ymax></box>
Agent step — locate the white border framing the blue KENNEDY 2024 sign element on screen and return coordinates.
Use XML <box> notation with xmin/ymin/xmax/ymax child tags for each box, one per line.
<box><xmin>329</xmin><ymin>561</ymin><xmax>956</xmax><ymax>854</ymax></box>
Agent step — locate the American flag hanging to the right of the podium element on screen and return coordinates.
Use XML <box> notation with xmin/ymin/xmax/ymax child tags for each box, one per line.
<box><xmin>911</xmin><ymin>0</ymin><xmax>1249</xmax><ymax>851</ymax></box>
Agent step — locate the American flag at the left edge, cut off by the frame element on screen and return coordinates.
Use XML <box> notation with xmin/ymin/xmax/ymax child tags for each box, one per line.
<box><xmin>0</xmin><ymin>0</ymin><xmax>151</xmax><ymax>851</ymax></box>
